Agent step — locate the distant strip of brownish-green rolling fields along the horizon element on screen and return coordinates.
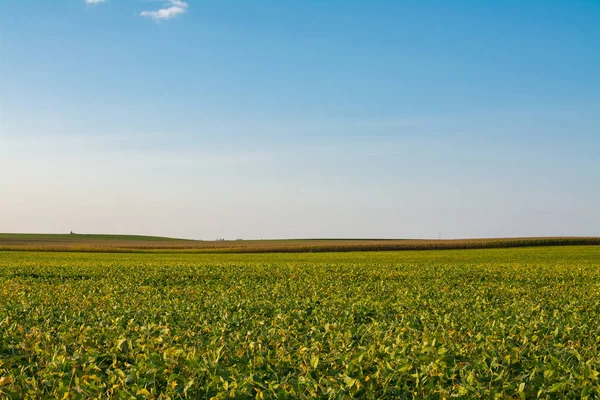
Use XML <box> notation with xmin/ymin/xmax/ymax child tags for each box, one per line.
<box><xmin>0</xmin><ymin>233</ymin><xmax>600</xmax><ymax>253</ymax></box>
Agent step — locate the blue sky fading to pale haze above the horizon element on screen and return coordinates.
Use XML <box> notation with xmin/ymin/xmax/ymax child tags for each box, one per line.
<box><xmin>0</xmin><ymin>0</ymin><xmax>600</xmax><ymax>239</ymax></box>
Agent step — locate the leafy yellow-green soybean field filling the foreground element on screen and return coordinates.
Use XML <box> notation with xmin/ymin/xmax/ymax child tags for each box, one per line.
<box><xmin>0</xmin><ymin>246</ymin><xmax>600</xmax><ymax>399</ymax></box>
